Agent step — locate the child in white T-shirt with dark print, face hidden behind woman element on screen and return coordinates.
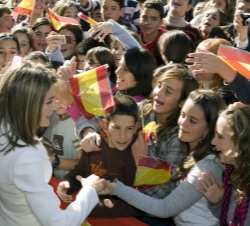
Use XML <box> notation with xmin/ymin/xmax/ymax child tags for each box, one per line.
<box><xmin>43</xmin><ymin>82</ymin><xmax>83</xmax><ymax>179</ymax></box>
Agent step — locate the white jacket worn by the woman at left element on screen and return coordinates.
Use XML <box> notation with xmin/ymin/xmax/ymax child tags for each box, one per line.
<box><xmin>0</xmin><ymin>137</ymin><xmax>99</xmax><ymax>226</ymax></box>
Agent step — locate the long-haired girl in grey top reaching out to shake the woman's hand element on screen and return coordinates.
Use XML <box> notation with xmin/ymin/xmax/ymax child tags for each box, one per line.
<box><xmin>100</xmin><ymin>90</ymin><xmax>227</xmax><ymax>226</ymax></box>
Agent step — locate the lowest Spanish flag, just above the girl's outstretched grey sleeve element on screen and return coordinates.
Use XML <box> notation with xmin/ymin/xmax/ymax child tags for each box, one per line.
<box><xmin>134</xmin><ymin>156</ymin><xmax>172</xmax><ymax>190</ymax></box>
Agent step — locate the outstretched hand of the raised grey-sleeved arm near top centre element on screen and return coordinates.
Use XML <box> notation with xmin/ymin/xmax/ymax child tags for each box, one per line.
<box><xmin>88</xmin><ymin>22</ymin><xmax>113</xmax><ymax>42</ymax></box>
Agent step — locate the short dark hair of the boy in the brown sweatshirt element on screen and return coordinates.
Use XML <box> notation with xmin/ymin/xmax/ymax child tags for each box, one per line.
<box><xmin>105</xmin><ymin>94</ymin><xmax>139</xmax><ymax>124</ymax></box>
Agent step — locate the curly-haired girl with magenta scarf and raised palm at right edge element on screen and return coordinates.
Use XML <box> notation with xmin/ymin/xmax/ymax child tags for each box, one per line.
<box><xmin>197</xmin><ymin>106</ymin><xmax>250</xmax><ymax>226</ymax></box>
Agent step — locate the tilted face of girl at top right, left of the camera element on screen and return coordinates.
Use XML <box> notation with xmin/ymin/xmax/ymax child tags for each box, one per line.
<box><xmin>200</xmin><ymin>9</ymin><xmax>220</xmax><ymax>34</ymax></box>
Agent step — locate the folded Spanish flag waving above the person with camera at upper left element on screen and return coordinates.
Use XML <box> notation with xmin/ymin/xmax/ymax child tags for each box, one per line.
<box><xmin>49</xmin><ymin>9</ymin><xmax>79</xmax><ymax>31</ymax></box>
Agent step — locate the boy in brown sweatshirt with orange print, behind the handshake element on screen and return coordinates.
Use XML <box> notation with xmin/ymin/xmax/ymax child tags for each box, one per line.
<box><xmin>57</xmin><ymin>95</ymin><xmax>141</xmax><ymax>217</ymax></box>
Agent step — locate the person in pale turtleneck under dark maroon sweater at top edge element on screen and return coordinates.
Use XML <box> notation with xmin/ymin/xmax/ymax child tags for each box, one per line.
<box><xmin>161</xmin><ymin>0</ymin><xmax>200</xmax><ymax>45</ymax></box>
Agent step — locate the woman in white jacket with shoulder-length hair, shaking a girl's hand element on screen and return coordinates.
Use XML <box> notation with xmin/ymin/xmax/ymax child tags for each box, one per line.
<box><xmin>0</xmin><ymin>62</ymin><xmax>101</xmax><ymax>226</ymax></box>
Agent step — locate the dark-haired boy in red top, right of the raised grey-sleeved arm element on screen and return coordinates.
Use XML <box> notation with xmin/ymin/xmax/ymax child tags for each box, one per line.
<box><xmin>138</xmin><ymin>0</ymin><xmax>164</xmax><ymax>65</ymax></box>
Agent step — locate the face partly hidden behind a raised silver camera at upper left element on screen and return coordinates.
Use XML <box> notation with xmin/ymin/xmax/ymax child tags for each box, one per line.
<box><xmin>59</xmin><ymin>29</ymin><xmax>77</xmax><ymax>58</ymax></box>
